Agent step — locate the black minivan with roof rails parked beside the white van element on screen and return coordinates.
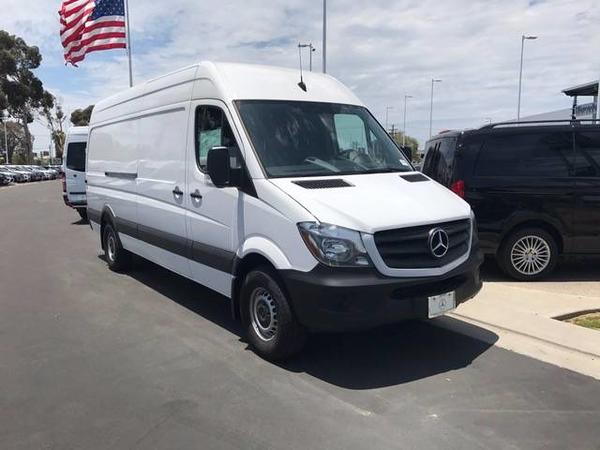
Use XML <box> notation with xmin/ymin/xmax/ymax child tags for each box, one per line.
<box><xmin>423</xmin><ymin>121</ymin><xmax>600</xmax><ymax>280</ymax></box>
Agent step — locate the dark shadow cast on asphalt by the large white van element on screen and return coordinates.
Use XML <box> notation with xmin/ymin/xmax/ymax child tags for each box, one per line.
<box><xmin>118</xmin><ymin>258</ymin><xmax>497</xmax><ymax>389</ymax></box>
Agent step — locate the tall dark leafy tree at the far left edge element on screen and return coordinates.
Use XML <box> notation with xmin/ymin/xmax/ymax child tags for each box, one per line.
<box><xmin>0</xmin><ymin>30</ymin><xmax>45</xmax><ymax>161</ymax></box>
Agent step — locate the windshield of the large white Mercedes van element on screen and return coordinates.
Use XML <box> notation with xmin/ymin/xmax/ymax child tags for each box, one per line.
<box><xmin>236</xmin><ymin>100</ymin><xmax>414</xmax><ymax>178</ymax></box>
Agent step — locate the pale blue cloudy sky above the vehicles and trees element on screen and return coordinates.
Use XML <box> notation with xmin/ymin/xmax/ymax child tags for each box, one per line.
<box><xmin>0</xmin><ymin>0</ymin><xmax>600</xmax><ymax>153</ymax></box>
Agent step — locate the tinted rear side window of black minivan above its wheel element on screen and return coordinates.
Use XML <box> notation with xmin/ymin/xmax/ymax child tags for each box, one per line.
<box><xmin>477</xmin><ymin>132</ymin><xmax>574</xmax><ymax>177</ymax></box>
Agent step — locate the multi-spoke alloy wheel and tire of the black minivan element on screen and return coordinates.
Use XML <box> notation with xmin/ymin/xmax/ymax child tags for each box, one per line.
<box><xmin>498</xmin><ymin>228</ymin><xmax>559</xmax><ymax>281</ymax></box>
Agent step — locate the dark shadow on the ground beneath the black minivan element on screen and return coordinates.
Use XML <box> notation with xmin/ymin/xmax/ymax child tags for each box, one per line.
<box><xmin>481</xmin><ymin>256</ymin><xmax>600</xmax><ymax>283</ymax></box>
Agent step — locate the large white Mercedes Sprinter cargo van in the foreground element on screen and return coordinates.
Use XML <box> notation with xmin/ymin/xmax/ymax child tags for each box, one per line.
<box><xmin>87</xmin><ymin>62</ymin><xmax>482</xmax><ymax>359</ymax></box>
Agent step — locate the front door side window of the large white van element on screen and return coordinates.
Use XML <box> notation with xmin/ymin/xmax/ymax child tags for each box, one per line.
<box><xmin>195</xmin><ymin>106</ymin><xmax>237</xmax><ymax>171</ymax></box>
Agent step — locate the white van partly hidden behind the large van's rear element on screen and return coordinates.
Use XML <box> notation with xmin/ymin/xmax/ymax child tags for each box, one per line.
<box><xmin>63</xmin><ymin>127</ymin><xmax>88</xmax><ymax>220</ymax></box>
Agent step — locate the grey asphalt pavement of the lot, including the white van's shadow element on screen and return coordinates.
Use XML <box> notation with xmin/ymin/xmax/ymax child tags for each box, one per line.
<box><xmin>0</xmin><ymin>182</ymin><xmax>600</xmax><ymax>450</ymax></box>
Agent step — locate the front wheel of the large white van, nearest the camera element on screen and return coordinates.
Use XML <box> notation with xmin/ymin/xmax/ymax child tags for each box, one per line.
<box><xmin>240</xmin><ymin>267</ymin><xmax>306</xmax><ymax>361</ymax></box>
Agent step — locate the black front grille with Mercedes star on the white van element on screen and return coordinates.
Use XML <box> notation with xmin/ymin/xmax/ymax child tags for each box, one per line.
<box><xmin>374</xmin><ymin>219</ymin><xmax>471</xmax><ymax>269</ymax></box>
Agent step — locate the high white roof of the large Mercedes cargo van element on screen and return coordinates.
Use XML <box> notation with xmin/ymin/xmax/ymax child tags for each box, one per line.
<box><xmin>91</xmin><ymin>61</ymin><xmax>363</xmax><ymax>124</ymax></box>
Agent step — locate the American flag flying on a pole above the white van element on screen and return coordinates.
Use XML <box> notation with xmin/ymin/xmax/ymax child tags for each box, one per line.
<box><xmin>58</xmin><ymin>0</ymin><xmax>127</xmax><ymax>66</ymax></box>
